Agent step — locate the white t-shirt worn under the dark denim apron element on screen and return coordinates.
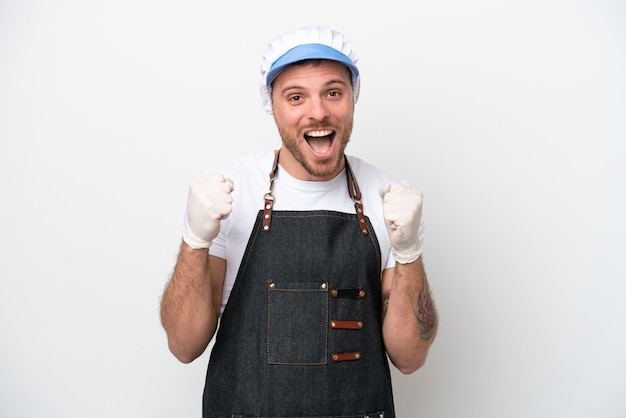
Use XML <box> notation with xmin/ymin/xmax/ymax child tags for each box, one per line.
<box><xmin>199</xmin><ymin>151</ymin><xmax>422</xmax><ymax>312</ymax></box>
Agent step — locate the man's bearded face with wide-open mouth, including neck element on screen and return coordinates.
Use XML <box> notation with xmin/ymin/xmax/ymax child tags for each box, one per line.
<box><xmin>272</xmin><ymin>60</ymin><xmax>354</xmax><ymax>181</ymax></box>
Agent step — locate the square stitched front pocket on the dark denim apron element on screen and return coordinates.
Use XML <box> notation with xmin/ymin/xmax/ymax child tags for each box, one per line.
<box><xmin>267</xmin><ymin>281</ymin><xmax>329</xmax><ymax>365</ymax></box>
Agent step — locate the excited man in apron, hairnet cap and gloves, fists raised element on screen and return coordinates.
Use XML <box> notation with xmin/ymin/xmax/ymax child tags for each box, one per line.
<box><xmin>161</xmin><ymin>26</ymin><xmax>437</xmax><ymax>417</ymax></box>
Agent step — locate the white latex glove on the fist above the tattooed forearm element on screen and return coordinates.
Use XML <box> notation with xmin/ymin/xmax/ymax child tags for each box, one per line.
<box><xmin>378</xmin><ymin>183</ymin><xmax>422</xmax><ymax>264</ymax></box>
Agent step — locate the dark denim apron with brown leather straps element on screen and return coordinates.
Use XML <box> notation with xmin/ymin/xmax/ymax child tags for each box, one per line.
<box><xmin>203</xmin><ymin>152</ymin><xmax>395</xmax><ymax>418</ymax></box>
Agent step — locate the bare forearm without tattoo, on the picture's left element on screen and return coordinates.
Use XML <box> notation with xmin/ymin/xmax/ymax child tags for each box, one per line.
<box><xmin>161</xmin><ymin>243</ymin><xmax>217</xmax><ymax>363</ymax></box>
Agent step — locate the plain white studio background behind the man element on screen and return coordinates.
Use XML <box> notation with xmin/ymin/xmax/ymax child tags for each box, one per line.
<box><xmin>0</xmin><ymin>0</ymin><xmax>626</xmax><ymax>418</ymax></box>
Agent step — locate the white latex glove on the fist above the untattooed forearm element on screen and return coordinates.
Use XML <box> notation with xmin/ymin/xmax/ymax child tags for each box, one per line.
<box><xmin>183</xmin><ymin>174</ymin><xmax>234</xmax><ymax>250</ymax></box>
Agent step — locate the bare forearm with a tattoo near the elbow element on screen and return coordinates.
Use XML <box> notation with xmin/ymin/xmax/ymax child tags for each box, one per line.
<box><xmin>383</xmin><ymin>258</ymin><xmax>437</xmax><ymax>373</ymax></box>
